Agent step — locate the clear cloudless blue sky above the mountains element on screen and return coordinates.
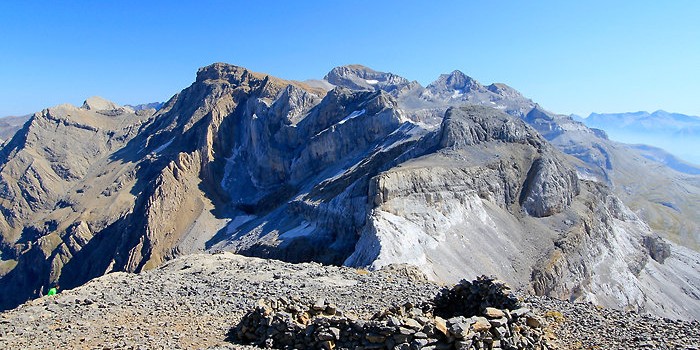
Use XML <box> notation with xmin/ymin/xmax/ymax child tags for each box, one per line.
<box><xmin>0</xmin><ymin>0</ymin><xmax>700</xmax><ymax>116</ymax></box>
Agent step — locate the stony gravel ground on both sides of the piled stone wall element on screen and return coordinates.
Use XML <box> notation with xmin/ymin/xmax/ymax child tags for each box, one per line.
<box><xmin>0</xmin><ymin>253</ymin><xmax>700</xmax><ymax>349</ymax></box>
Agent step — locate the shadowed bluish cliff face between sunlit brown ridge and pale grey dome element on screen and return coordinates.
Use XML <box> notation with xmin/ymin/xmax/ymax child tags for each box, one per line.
<box><xmin>210</xmin><ymin>80</ymin><xmax>424</xmax><ymax>264</ymax></box>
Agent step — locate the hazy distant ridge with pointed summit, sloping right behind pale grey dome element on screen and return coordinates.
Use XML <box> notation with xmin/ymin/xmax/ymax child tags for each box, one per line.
<box><xmin>330</xmin><ymin>67</ymin><xmax>700</xmax><ymax>250</ymax></box>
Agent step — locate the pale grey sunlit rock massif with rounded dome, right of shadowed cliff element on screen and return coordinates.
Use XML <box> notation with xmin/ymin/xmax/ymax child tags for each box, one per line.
<box><xmin>346</xmin><ymin>106</ymin><xmax>697</xmax><ymax>317</ymax></box>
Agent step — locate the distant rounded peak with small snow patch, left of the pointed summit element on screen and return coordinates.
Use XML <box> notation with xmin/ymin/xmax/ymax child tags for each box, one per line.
<box><xmin>323</xmin><ymin>64</ymin><xmax>410</xmax><ymax>91</ymax></box>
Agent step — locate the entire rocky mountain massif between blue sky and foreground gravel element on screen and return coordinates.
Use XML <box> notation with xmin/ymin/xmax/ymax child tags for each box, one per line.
<box><xmin>0</xmin><ymin>63</ymin><xmax>700</xmax><ymax>318</ymax></box>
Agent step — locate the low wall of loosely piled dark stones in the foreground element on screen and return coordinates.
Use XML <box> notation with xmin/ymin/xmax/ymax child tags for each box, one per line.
<box><xmin>228</xmin><ymin>276</ymin><xmax>548</xmax><ymax>350</ymax></box>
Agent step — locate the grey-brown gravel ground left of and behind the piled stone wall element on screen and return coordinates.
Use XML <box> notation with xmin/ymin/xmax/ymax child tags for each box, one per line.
<box><xmin>0</xmin><ymin>253</ymin><xmax>440</xmax><ymax>349</ymax></box>
